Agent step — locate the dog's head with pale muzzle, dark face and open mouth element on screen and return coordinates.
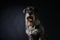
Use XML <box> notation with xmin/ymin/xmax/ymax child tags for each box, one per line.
<box><xmin>23</xmin><ymin>7</ymin><xmax>36</xmax><ymax>26</ymax></box>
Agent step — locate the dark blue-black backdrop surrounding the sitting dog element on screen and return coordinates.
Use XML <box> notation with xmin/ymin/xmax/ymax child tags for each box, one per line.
<box><xmin>0</xmin><ymin>0</ymin><xmax>59</xmax><ymax>40</ymax></box>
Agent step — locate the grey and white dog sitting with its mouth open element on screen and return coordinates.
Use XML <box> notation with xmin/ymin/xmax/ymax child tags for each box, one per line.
<box><xmin>23</xmin><ymin>6</ymin><xmax>45</xmax><ymax>40</ymax></box>
